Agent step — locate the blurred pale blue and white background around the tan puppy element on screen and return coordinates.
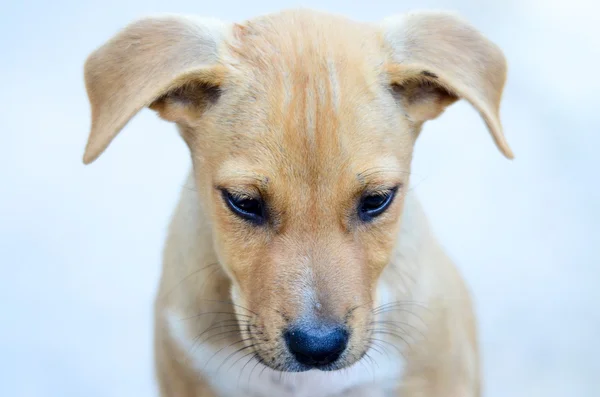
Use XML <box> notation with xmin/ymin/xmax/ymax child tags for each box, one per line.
<box><xmin>0</xmin><ymin>0</ymin><xmax>600</xmax><ymax>397</ymax></box>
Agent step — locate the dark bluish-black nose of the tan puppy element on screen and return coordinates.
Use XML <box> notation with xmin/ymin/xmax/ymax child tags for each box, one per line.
<box><xmin>284</xmin><ymin>324</ymin><xmax>348</xmax><ymax>367</ymax></box>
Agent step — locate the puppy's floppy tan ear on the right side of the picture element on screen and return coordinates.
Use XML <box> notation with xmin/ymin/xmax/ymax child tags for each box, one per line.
<box><xmin>381</xmin><ymin>11</ymin><xmax>513</xmax><ymax>158</ymax></box>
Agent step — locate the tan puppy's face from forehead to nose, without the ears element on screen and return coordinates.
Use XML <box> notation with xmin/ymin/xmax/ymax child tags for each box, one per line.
<box><xmin>198</xmin><ymin>19</ymin><xmax>416</xmax><ymax>371</ymax></box>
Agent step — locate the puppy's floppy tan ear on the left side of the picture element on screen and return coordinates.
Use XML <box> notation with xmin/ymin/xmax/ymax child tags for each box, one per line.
<box><xmin>83</xmin><ymin>16</ymin><xmax>227</xmax><ymax>164</ymax></box>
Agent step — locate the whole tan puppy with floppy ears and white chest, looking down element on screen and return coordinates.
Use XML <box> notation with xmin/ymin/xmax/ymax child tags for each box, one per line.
<box><xmin>84</xmin><ymin>10</ymin><xmax>512</xmax><ymax>397</ymax></box>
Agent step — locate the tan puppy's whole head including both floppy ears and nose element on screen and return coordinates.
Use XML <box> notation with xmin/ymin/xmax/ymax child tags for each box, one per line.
<box><xmin>84</xmin><ymin>11</ymin><xmax>512</xmax><ymax>371</ymax></box>
